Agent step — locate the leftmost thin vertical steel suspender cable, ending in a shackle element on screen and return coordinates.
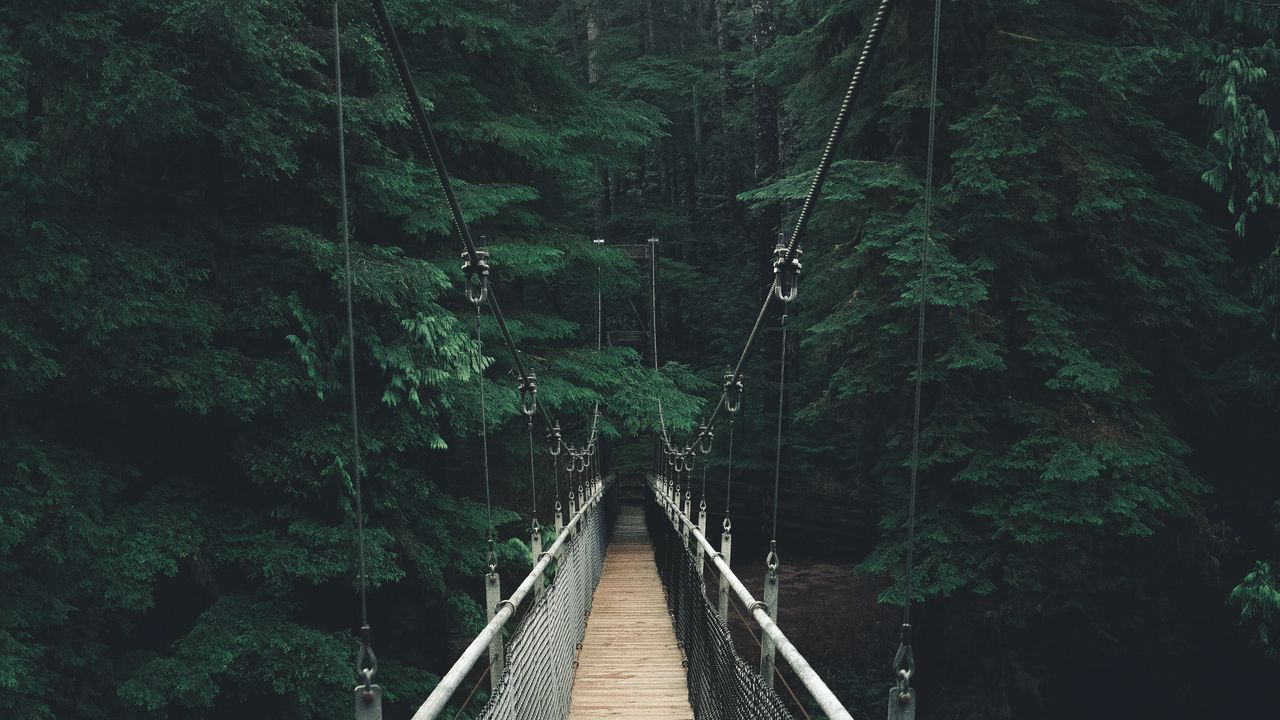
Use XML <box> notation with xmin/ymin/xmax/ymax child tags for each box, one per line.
<box><xmin>333</xmin><ymin>0</ymin><xmax>378</xmax><ymax>688</ymax></box>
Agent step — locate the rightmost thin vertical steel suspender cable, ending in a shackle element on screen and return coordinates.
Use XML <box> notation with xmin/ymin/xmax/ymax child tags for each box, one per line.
<box><xmin>893</xmin><ymin>0</ymin><xmax>942</xmax><ymax>692</ymax></box>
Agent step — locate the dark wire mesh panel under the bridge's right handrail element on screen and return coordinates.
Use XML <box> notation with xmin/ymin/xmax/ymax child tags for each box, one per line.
<box><xmin>645</xmin><ymin>489</ymin><xmax>794</xmax><ymax>720</ymax></box>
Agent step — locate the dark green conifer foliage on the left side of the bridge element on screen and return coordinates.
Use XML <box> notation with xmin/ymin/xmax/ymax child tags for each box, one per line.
<box><xmin>0</xmin><ymin>0</ymin><xmax>680</xmax><ymax>717</ymax></box>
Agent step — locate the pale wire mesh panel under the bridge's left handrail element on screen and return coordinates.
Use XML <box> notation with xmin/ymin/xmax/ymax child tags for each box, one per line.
<box><xmin>479</xmin><ymin>493</ymin><xmax>609</xmax><ymax>720</ymax></box>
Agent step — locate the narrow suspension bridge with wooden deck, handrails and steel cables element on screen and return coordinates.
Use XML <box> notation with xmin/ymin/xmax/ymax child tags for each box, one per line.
<box><xmin>333</xmin><ymin>0</ymin><xmax>940</xmax><ymax>720</ymax></box>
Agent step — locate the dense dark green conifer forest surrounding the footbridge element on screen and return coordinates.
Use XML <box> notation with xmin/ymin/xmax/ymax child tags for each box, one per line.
<box><xmin>0</xmin><ymin>0</ymin><xmax>1280</xmax><ymax>720</ymax></box>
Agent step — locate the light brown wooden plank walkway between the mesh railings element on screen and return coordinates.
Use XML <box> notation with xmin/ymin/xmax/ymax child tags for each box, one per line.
<box><xmin>568</xmin><ymin>505</ymin><xmax>694</xmax><ymax>720</ymax></box>
